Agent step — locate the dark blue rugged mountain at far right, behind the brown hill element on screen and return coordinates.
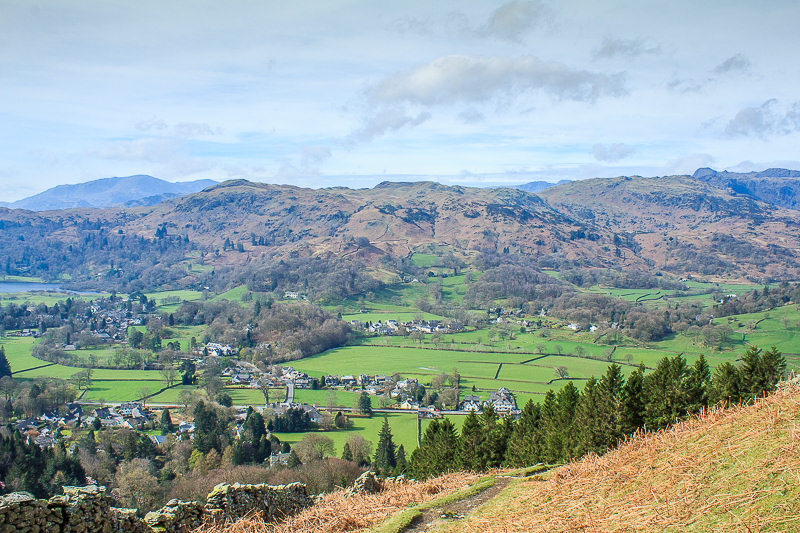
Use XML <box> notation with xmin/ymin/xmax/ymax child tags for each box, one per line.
<box><xmin>693</xmin><ymin>168</ymin><xmax>800</xmax><ymax>210</ymax></box>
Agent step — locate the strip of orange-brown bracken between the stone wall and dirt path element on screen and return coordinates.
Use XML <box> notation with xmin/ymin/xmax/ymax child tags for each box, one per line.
<box><xmin>202</xmin><ymin>473</ymin><xmax>479</xmax><ymax>533</ymax></box>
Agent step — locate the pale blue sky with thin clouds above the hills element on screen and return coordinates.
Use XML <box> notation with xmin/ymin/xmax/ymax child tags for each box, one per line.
<box><xmin>0</xmin><ymin>0</ymin><xmax>800</xmax><ymax>201</ymax></box>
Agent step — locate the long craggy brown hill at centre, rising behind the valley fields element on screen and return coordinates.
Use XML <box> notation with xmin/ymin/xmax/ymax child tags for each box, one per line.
<box><xmin>139</xmin><ymin>180</ymin><xmax>610</xmax><ymax>261</ymax></box>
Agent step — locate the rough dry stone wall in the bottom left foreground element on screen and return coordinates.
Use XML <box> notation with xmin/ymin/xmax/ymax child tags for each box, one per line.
<box><xmin>0</xmin><ymin>483</ymin><xmax>313</xmax><ymax>533</ymax></box>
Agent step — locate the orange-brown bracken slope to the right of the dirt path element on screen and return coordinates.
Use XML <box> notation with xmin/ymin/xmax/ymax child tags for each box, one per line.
<box><xmin>444</xmin><ymin>389</ymin><xmax>800</xmax><ymax>533</ymax></box>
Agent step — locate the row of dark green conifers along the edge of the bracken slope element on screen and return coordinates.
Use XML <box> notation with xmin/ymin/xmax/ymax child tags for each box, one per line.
<box><xmin>404</xmin><ymin>347</ymin><xmax>786</xmax><ymax>478</ymax></box>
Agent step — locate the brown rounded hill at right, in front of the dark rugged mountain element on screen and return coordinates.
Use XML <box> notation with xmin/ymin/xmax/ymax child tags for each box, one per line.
<box><xmin>539</xmin><ymin>176</ymin><xmax>800</xmax><ymax>279</ymax></box>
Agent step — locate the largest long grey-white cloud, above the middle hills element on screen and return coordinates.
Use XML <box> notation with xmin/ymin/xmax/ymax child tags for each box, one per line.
<box><xmin>369</xmin><ymin>55</ymin><xmax>626</xmax><ymax>105</ymax></box>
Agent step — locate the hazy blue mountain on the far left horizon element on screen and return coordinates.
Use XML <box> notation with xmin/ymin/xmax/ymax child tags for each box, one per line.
<box><xmin>0</xmin><ymin>175</ymin><xmax>217</xmax><ymax>211</ymax></box>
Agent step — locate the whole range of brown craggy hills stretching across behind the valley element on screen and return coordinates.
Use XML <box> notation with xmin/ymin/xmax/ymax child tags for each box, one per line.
<box><xmin>0</xmin><ymin>169</ymin><xmax>800</xmax><ymax>285</ymax></box>
